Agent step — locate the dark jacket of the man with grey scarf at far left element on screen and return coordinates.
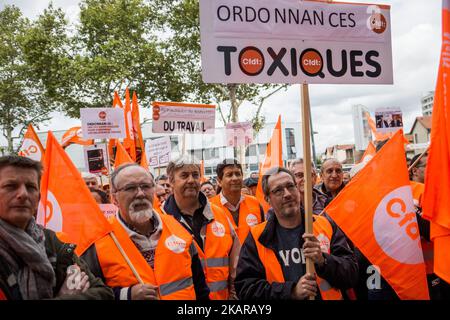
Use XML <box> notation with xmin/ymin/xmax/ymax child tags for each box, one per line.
<box><xmin>0</xmin><ymin>229</ymin><xmax>114</xmax><ymax>300</ymax></box>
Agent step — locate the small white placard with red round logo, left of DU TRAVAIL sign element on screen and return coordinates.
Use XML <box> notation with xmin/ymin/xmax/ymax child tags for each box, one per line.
<box><xmin>80</xmin><ymin>108</ymin><xmax>126</xmax><ymax>139</ymax></box>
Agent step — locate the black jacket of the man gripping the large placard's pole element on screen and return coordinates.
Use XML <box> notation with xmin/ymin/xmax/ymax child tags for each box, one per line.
<box><xmin>235</xmin><ymin>209</ymin><xmax>358</xmax><ymax>300</ymax></box>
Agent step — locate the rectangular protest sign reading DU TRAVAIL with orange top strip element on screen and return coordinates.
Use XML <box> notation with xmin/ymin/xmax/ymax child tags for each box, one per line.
<box><xmin>152</xmin><ymin>102</ymin><xmax>216</xmax><ymax>134</ymax></box>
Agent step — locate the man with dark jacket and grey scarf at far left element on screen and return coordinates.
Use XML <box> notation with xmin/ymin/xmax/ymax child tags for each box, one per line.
<box><xmin>0</xmin><ymin>155</ymin><xmax>113</xmax><ymax>300</ymax></box>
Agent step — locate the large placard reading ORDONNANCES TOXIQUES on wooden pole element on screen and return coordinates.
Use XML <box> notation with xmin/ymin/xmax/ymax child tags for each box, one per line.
<box><xmin>200</xmin><ymin>0</ymin><xmax>393</xmax><ymax>84</ymax></box>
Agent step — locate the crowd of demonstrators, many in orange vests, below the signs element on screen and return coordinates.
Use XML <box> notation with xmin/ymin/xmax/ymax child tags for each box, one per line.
<box><xmin>0</xmin><ymin>150</ymin><xmax>449</xmax><ymax>300</ymax></box>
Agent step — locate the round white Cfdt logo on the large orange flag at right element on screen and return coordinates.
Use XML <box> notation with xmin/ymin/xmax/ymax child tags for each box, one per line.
<box><xmin>373</xmin><ymin>186</ymin><xmax>423</xmax><ymax>264</ymax></box>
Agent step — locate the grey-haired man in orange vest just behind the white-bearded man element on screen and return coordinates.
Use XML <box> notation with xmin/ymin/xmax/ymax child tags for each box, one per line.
<box><xmin>161</xmin><ymin>155</ymin><xmax>240</xmax><ymax>300</ymax></box>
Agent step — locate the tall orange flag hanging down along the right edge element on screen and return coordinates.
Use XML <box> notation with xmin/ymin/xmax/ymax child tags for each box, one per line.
<box><xmin>422</xmin><ymin>0</ymin><xmax>450</xmax><ymax>283</ymax></box>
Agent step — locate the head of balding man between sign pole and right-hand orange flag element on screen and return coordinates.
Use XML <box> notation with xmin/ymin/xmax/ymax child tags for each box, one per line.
<box><xmin>318</xmin><ymin>159</ymin><xmax>345</xmax><ymax>199</ymax></box>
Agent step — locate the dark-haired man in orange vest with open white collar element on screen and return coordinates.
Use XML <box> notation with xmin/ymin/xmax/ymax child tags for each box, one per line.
<box><xmin>210</xmin><ymin>159</ymin><xmax>264</xmax><ymax>243</ymax></box>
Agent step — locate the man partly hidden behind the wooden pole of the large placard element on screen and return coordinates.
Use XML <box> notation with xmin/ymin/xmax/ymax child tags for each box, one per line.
<box><xmin>290</xmin><ymin>158</ymin><xmax>330</xmax><ymax>214</ymax></box>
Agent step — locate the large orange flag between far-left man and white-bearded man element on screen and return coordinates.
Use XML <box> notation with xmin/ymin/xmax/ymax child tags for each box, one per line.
<box><xmin>37</xmin><ymin>132</ymin><xmax>112</xmax><ymax>255</ymax></box>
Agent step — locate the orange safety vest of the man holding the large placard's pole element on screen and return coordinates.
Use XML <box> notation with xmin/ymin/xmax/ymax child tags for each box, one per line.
<box><xmin>250</xmin><ymin>216</ymin><xmax>343</xmax><ymax>300</ymax></box>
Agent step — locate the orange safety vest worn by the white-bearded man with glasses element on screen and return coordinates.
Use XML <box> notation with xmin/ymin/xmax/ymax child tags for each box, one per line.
<box><xmin>95</xmin><ymin>215</ymin><xmax>196</xmax><ymax>300</ymax></box>
